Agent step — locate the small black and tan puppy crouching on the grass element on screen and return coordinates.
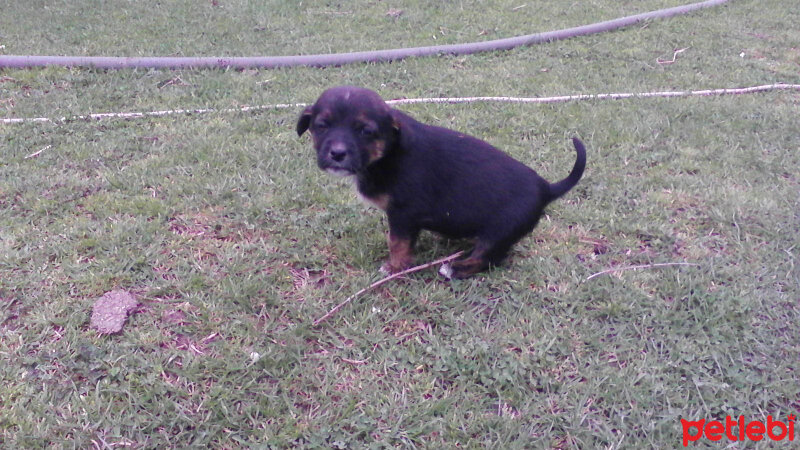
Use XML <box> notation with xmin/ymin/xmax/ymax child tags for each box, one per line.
<box><xmin>297</xmin><ymin>86</ymin><xmax>586</xmax><ymax>278</ymax></box>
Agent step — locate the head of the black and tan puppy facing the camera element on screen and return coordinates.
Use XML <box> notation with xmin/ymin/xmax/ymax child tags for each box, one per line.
<box><xmin>297</xmin><ymin>86</ymin><xmax>400</xmax><ymax>176</ymax></box>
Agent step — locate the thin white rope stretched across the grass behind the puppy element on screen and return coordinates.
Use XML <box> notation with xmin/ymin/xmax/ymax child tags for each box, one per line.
<box><xmin>0</xmin><ymin>84</ymin><xmax>800</xmax><ymax>125</ymax></box>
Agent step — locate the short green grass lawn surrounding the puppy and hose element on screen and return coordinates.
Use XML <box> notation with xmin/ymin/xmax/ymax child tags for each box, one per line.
<box><xmin>0</xmin><ymin>0</ymin><xmax>800</xmax><ymax>448</ymax></box>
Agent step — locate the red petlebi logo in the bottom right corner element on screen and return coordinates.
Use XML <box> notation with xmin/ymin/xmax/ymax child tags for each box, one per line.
<box><xmin>681</xmin><ymin>414</ymin><xmax>795</xmax><ymax>447</ymax></box>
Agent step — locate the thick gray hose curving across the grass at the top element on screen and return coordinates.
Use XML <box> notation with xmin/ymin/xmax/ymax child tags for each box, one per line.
<box><xmin>0</xmin><ymin>0</ymin><xmax>728</xmax><ymax>69</ymax></box>
